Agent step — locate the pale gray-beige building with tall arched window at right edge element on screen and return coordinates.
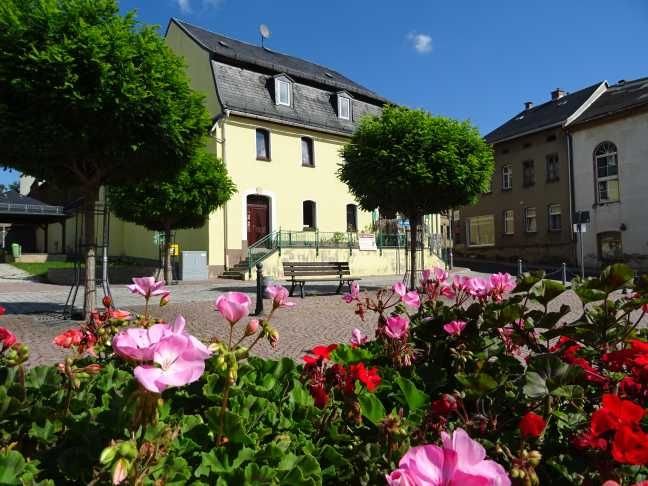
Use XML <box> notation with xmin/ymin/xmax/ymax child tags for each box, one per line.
<box><xmin>569</xmin><ymin>78</ymin><xmax>648</xmax><ymax>272</ymax></box>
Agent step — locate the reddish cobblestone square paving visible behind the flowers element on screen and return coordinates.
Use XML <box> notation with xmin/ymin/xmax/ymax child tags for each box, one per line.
<box><xmin>0</xmin><ymin>270</ymin><xmax>486</xmax><ymax>366</ymax></box>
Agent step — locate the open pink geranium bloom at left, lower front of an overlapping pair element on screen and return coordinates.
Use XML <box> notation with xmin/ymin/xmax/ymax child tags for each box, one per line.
<box><xmin>133</xmin><ymin>334</ymin><xmax>205</xmax><ymax>393</ymax></box>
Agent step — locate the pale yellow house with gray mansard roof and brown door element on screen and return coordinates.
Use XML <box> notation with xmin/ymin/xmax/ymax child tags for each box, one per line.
<box><xmin>39</xmin><ymin>19</ymin><xmax>446</xmax><ymax>278</ymax></box>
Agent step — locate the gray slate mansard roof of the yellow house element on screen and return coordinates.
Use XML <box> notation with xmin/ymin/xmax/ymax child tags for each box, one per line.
<box><xmin>171</xmin><ymin>19</ymin><xmax>387</xmax><ymax>134</ymax></box>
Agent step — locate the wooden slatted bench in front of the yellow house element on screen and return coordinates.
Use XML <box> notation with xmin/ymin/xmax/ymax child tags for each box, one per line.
<box><xmin>283</xmin><ymin>262</ymin><xmax>361</xmax><ymax>299</ymax></box>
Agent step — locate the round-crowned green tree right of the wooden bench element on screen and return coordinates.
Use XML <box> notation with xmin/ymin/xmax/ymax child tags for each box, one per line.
<box><xmin>338</xmin><ymin>106</ymin><xmax>494</xmax><ymax>288</ymax></box>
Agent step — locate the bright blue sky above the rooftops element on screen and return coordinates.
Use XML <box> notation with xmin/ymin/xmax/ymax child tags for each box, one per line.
<box><xmin>0</xmin><ymin>0</ymin><xmax>648</xmax><ymax>183</ymax></box>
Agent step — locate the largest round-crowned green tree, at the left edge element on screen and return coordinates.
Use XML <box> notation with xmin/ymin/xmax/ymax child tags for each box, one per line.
<box><xmin>0</xmin><ymin>0</ymin><xmax>211</xmax><ymax>313</ymax></box>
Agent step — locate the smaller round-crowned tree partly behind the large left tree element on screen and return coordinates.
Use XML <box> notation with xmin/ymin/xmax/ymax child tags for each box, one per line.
<box><xmin>108</xmin><ymin>150</ymin><xmax>236</xmax><ymax>282</ymax></box>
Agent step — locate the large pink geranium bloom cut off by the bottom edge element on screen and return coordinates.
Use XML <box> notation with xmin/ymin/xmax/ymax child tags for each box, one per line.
<box><xmin>387</xmin><ymin>429</ymin><xmax>511</xmax><ymax>486</ymax></box>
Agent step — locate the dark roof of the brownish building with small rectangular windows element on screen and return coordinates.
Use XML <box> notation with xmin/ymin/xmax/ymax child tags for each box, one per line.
<box><xmin>485</xmin><ymin>83</ymin><xmax>601</xmax><ymax>143</ymax></box>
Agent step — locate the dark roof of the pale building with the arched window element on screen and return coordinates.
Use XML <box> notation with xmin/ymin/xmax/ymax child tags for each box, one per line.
<box><xmin>574</xmin><ymin>78</ymin><xmax>648</xmax><ymax>124</ymax></box>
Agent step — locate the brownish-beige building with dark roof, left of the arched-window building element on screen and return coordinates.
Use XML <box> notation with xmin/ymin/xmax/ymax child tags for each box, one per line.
<box><xmin>453</xmin><ymin>83</ymin><xmax>605</xmax><ymax>264</ymax></box>
